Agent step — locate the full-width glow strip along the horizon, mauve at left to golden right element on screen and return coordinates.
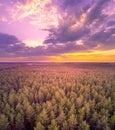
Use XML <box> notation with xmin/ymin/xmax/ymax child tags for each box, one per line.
<box><xmin>0</xmin><ymin>49</ymin><xmax>115</xmax><ymax>62</ymax></box>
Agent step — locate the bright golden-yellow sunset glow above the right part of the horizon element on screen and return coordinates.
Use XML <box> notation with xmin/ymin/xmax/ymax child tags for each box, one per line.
<box><xmin>50</xmin><ymin>49</ymin><xmax>115</xmax><ymax>62</ymax></box>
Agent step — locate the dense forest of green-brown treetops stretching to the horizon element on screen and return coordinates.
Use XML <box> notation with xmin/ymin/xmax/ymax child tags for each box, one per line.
<box><xmin>0</xmin><ymin>63</ymin><xmax>115</xmax><ymax>130</ymax></box>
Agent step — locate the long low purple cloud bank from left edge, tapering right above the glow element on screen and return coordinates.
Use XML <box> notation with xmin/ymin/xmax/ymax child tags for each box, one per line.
<box><xmin>0</xmin><ymin>33</ymin><xmax>86</xmax><ymax>57</ymax></box>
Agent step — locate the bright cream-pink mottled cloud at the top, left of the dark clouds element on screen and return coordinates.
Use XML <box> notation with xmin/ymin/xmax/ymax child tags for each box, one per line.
<box><xmin>8</xmin><ymin>0</ymin><xmax>58</xmax><ymax>29</ymax></box>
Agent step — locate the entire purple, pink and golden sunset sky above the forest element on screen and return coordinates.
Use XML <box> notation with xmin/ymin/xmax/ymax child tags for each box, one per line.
<box><xmin>0</xmin><ymin>0</ymin><xmax>115</xmax><ymax>62</ymax></box>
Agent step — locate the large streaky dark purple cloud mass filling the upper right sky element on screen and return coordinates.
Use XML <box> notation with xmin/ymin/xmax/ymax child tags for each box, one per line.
<box><xmin>44</xmin><ymin>0</ymin><xmax>115</xmax><ymax>51</ymax></box>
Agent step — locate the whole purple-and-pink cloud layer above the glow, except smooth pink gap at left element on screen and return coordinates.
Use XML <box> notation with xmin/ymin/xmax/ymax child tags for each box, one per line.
<box><xmin>0</xmin><ymin>0</ymin><xmax>115</xmax><ymax>57</ymax></box>
